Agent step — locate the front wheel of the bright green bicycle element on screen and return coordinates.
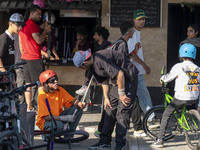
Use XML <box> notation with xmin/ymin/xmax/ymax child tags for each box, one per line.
<box><xmin>142</xmin><ymin>105</ymin><xmax>177</xmax><ymax>140</ymax></box>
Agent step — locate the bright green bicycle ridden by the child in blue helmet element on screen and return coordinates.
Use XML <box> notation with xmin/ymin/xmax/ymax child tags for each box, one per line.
<box><xmin>143</xmin><ymin>67</ymin><xmax>200</xmax><ymax>149</ymax></box>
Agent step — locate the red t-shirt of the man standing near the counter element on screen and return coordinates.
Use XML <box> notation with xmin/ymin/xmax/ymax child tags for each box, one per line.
<box><xmin>19</xmin><ymin>19</ymin><xmax>42</xmax><ymax>60</ymax></box>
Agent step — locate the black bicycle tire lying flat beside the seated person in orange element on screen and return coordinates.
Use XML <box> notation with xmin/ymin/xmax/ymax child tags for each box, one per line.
<box><xmin>54</xmin><ymin>130</ymin><xmax>89</xmax><ymax>143</ymax></box>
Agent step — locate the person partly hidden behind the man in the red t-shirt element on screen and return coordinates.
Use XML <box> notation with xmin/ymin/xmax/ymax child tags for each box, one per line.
<box><xmin>40</xmin><ymin>17</ymin><xmax>60</xmax><ymax>60</ymax></box>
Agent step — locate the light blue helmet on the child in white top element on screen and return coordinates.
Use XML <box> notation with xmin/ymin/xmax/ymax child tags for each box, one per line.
<box><xmin>179</xmin><ymin>43</ymin><xmax>196</xmax><ymax>59</ymax></box>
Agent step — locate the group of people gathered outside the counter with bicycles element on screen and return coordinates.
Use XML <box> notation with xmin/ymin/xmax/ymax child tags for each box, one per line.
<box><xmin>0</xmin><ymin>2</ymin><xmax>200</xmax><ymax>150</ymax></box>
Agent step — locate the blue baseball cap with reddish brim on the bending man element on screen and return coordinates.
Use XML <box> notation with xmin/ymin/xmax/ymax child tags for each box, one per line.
<box><xmin>73</xmin><ymin>49</ymin><xmax>92</xmax><ymax>67</ymax></box>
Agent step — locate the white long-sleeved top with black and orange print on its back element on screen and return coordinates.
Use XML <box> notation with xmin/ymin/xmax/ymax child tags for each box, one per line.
<box><xmin>161</xmin><ymin>61</ymin><xmax>200</xmax><ymax>100</ymax></box>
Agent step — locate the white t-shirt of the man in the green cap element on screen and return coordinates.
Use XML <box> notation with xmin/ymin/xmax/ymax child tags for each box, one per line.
<box><xmin>128</xmin><ymin>29</ymin><xmax>146</xmax><ymax>75</ymax></box>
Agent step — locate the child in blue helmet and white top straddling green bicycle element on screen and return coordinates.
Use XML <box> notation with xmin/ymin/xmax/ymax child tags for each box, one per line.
<box><xmin>152</xmin><ymin>43</ymin><xmax>200</xmax><ymax>147</ymax></box>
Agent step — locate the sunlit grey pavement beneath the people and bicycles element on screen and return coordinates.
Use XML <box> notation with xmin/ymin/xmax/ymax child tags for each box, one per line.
<box><xmin>34</xmin><ymin>108</ymin><xmax>190</xmax><ymax>150</ymax></box>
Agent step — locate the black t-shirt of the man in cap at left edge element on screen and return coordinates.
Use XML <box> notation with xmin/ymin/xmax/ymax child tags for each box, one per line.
<box><xmin>0</xmin><ymin>32</ymin><xmax>14</xmax><ymax>67</ymax></box>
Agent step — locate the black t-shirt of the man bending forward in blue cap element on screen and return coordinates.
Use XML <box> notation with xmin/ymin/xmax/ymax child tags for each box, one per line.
<box><xmin>91</xmin><ymin>48</ymin><xmax>138</xmax><ymax>84</ymax></box>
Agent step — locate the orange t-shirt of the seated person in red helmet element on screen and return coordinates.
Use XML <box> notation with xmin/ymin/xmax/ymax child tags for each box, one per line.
<box><xmin>36</xmin><ymin>86</ymin><xmax>75</xmax><ymax>130</ymax></box>
